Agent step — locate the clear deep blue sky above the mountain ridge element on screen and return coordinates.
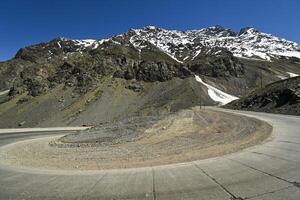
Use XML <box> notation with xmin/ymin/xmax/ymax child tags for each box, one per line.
<box><xmin>0</xmin><ymin>0</ymin><xmax>300</xmax><ymax>60</ymax></box>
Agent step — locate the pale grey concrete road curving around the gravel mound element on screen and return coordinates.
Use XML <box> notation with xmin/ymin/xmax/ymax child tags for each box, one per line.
<box><xmin>0</xmin><ymin>108</ymin><xmax>300</xmax><ymax>200</ymax></box>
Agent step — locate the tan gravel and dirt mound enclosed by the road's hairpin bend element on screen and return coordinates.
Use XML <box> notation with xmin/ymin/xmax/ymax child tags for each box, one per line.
<box><xmin>0</xmin><ymin>107</ymin><xmax>272</xmax><ymax>170</ymax></box>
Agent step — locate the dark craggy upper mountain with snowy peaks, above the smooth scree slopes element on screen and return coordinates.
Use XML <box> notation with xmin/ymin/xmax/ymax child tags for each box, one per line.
<box><xmin>4</xmin><ymin>26</ymin><xmax>300</xmax><ymax>98</ymax></box>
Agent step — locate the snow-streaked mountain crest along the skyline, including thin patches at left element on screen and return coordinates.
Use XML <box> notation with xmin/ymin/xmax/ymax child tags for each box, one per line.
<box><xmin>65</xmin><ymin>26</ymin><xmax>300</xmax><ymax>63</ymax></box>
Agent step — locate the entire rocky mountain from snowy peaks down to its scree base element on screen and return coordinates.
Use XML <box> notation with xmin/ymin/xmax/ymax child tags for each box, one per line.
<box><xmin>0</xmin><ymin>26</ymin><xmax>300</xmax><ymax>127</ymax></box>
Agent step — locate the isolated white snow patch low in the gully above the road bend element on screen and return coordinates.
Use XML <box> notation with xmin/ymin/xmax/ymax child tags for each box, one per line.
<box><xmin>195</xmin><ymin>75</ymin><xmax>238</xmax><ymax>105</ymax></box>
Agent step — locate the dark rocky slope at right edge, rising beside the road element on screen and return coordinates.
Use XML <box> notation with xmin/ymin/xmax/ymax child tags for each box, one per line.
<box><xmin>225</xmin><ymin>77</ymin><xmax>300</xmax><ymax>115</ymax></box>
